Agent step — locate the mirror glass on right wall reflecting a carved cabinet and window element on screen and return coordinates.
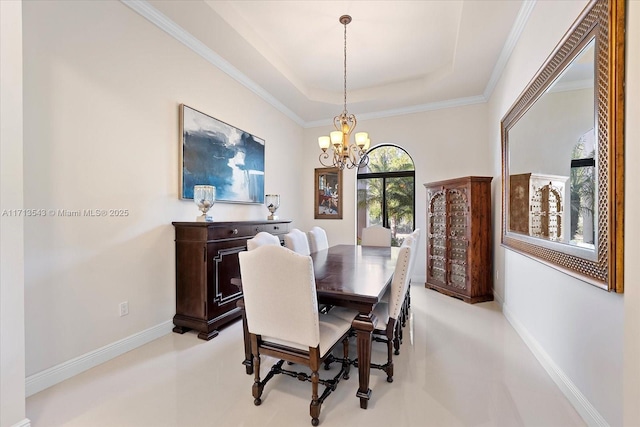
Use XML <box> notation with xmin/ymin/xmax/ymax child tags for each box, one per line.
<box><xmin>509</xmin><ymin>38</ymin><xmax>597</xmax><ymax>251</ymax></box>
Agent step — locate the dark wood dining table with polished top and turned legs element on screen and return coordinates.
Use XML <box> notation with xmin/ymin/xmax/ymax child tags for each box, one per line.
<box><xmin>238</xmin><ymin>245</ymin><xmax>400</xmax><ymax>409</ymax></box>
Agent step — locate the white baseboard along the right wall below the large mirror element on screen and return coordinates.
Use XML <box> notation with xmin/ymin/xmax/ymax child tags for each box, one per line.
<box><xmin>502</xmin><ymin>303</ymin><xmax>609</xmax><ymax>427</ymax></box>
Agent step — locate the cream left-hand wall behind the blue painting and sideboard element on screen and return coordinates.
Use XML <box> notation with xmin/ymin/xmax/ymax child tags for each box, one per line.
<box><xmin>21</xmin><ymin>1</ymin><xmax>303</xmax><ymax>375</ymax></box>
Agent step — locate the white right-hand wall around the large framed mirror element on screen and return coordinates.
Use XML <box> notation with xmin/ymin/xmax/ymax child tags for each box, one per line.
<box><xmin>489</xmin><ymin>1</ymin><xmax>624</xmax><ymax>426</ymax></box>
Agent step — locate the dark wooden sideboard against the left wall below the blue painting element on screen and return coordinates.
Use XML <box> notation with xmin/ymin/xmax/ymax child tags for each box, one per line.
<box><xmin>172</xmin><ymin>220</ymin><xmax>291</xmax><ymax>340</ymax></box>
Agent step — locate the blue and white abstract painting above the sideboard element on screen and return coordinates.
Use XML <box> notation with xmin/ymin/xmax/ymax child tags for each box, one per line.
<box><xmin>180</xmin><ymin>104</ymin><xmax>264</xmax><ymax>203</ymax></box>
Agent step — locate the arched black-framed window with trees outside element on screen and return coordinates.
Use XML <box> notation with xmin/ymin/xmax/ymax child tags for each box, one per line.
<box><xmin>357</xmin><ymin>145</ymin><xmax>415</xmax><ymax>246</ymax></box>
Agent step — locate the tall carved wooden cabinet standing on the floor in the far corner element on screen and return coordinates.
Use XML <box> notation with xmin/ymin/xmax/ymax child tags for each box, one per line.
<box><xmin>424</xmin><ymin>176</ymin><xmax>493</xmax><ymax>303</ymax></box>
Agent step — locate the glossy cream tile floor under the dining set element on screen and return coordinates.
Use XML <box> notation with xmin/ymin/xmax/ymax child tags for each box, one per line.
<box><xmin>27</xmin><ymin>285</ymin><xmax>585</xmax><ymax>427</ymax></box>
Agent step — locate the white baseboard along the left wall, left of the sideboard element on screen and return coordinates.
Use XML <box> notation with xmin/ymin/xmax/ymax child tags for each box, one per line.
<box><xmin>26</xmin><ymin>320</ymin><xmax>173</xmax><ymax>398</ymax></box>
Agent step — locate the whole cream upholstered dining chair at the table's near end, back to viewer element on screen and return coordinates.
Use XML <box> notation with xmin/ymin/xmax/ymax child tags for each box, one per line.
<box><xmin>238</xmin><ymin>245</ymin><xmax>351</xmax><ymax>426</ymax></box>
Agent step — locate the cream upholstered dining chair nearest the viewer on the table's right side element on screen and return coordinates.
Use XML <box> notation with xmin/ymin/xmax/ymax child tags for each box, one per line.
<box><xmin>371</xmin><ymin>237</ymin><xmax>413</xmax><ymax>382</ymax></box>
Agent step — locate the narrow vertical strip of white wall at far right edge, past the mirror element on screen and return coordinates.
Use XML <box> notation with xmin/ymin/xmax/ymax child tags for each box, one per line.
<box><xmin>623</xmin><ymin>0</ymin><xmax>640</xmax><ymax>426</ymax></box>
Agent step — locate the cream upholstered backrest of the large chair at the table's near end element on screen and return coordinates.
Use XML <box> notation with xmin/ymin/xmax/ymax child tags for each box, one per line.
<box><xmin>238</xmin><ymin>245</ymin><xmax>320</xmax><ymax>347</ymax></box>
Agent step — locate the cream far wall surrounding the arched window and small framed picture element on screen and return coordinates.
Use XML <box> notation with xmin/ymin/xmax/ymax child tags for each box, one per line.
<box><xmin>302</xmin><ymin>104</ymin><xmax>495</xmax><ymax>281</ymax></box>
